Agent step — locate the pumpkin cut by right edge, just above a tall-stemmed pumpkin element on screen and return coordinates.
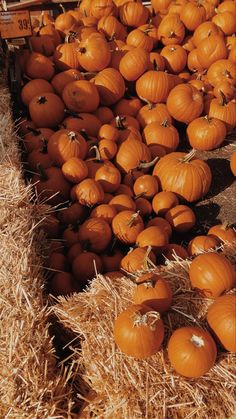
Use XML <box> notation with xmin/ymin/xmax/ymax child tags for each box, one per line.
<box><xmin>207</xmin><ymin>59</ymin><xmax>236</xmax><ymax>86</ymax></box>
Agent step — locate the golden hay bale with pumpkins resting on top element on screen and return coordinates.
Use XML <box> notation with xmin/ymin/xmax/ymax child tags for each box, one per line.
<box><xmin>54</xmin><ymin>251</ymin><xmax>236</xmax><ymax>419</ymax></box>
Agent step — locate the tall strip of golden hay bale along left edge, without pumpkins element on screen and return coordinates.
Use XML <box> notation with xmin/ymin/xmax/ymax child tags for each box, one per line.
<box><xmin>0</xmin><ymin>78</ymin><xmax>72</xmax><ymax>419</ymax></box>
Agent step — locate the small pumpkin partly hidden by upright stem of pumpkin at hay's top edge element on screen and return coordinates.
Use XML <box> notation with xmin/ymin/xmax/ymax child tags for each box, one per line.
<box><xmin>136</xmin><ymin>226</ymin><xmax>169</xmax><ymax>254</ymax></box>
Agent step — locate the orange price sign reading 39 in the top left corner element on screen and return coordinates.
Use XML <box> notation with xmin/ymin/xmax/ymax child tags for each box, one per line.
<box><xmin>0</xmin><ymin>10</ymin><xmax>32</xmax><ymax>39</ymax></box>
